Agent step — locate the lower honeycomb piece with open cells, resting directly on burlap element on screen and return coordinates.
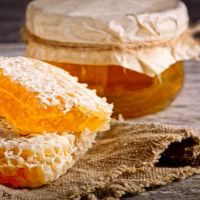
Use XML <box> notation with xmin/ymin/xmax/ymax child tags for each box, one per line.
<box><xmin>0</xmin><ymin>118</ymin><xmax>95</xmax><ymax>188</ymax></box>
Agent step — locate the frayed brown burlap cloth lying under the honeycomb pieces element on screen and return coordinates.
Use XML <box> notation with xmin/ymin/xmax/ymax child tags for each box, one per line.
<box><xmin>0</xmin><ymin>122</ymin><xmax>200</xmax><ymax>200</ymax></box>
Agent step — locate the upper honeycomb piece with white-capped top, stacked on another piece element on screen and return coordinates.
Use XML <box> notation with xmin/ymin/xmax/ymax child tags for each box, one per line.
<box><xmin>0</xmin><ymin>57</ymin><xmax>112</xmax><ymax>134</ymax></box>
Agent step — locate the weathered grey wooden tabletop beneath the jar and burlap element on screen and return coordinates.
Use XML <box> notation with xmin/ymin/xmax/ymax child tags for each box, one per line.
<box><xmin>0</xmin><ymin>44</ymin><xmax>200</xmax><ymax>200</ymax></box>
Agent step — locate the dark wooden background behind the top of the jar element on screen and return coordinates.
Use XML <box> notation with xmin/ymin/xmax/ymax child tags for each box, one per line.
<box><xmin>0</xmin><ymin>0</ymin><xmax>200</xmax><ymax>43</ymax></box>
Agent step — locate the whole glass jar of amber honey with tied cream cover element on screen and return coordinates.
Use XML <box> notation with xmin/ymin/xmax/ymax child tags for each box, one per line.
<box><xmin>25</xmin><ymin>0</ymin><xmax>200</xmax><ymax>118</ymax></box>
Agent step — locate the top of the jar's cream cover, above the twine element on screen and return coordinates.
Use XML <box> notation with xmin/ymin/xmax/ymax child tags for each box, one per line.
<box><xmin>26</xmin><ymin>0</ymin><xmax>188</xmax><ymax>44</ymax></box>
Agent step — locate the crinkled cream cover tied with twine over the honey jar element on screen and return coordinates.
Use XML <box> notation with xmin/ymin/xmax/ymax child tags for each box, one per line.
<box><xmin>26</xmin><ymin>0</ymin><xmax>200</xmax><ymax>76</ymax></box>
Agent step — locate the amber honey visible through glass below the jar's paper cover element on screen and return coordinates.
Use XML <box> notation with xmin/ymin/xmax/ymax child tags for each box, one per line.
<box><xmin>48</xmin><ymin>62</ymin><xmax>184</xmax><ymax>118</ymax></box>
